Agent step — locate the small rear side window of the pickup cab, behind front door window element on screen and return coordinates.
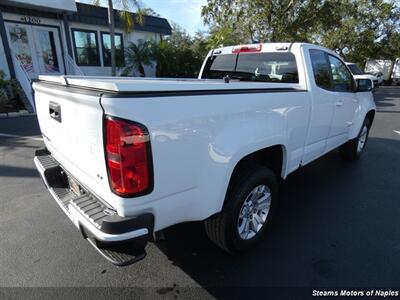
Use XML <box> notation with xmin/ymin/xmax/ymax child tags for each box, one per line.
<box><xmin>310</xmin><ymin>50</ymin><xmax>332</xmax><ymax>90</ymax></box>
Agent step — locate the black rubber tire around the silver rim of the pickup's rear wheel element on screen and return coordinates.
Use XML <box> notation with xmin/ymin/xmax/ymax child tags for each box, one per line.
<box><xmin>205</xmin><ymin>165</ymin><xmax>278</xmax><ymax>254</ymax></box>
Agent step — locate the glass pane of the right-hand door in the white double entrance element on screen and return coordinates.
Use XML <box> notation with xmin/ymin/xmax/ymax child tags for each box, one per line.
<box><xmin>32</xmin><ymin>26</ymin><xmax>64</xmax><ymax>75</ymax></box>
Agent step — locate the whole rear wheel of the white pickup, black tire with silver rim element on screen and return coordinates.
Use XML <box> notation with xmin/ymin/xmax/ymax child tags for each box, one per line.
<box><xmin>205</xmin><ymin>166</ymin><xmax>278</xmax><ymax>253</ymax></box>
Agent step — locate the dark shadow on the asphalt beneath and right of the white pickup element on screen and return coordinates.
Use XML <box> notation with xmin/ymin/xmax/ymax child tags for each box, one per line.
<box><xmin>156</xmin><ymin>138</ymin><xmax>400</xmax><ymax>298</ymax></box>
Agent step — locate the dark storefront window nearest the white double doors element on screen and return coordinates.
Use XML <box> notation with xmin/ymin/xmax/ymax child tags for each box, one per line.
<box><xmin>72</xmin><ymin>29</ymin><xmax>100</xmax><ymax>66</ymax></box>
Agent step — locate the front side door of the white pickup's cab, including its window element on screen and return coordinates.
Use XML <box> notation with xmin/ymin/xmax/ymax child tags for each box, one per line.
<box><xmin>326</xmin><ymin>54</ymin><xmax>358</xmax><ymax>151</ymax></box>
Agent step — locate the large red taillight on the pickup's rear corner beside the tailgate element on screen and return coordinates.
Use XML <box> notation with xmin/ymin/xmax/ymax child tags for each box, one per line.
<box><xmin>105</xmin><ymin>116</ymin><xmax>153</xmax><ymax>197</ymax></box>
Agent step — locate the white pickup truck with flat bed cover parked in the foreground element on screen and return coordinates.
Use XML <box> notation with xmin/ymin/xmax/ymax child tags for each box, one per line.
<box><xmin>33</xmin><ymin>43</ymin><xmax>375</xmax><ymax>265</ymax></box>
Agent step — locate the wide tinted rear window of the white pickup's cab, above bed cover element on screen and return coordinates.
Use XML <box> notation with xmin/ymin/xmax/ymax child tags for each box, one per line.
<box><xmin>202</xmin><ymin>52</ymin><xmax>299</xmax><ymax>83</ymax></box>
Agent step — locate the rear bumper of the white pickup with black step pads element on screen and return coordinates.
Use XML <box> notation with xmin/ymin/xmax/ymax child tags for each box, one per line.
<box><xmin>34</xmin><ymin>149</ymin><xmax>154</xmax><ymax>265</ymax></box>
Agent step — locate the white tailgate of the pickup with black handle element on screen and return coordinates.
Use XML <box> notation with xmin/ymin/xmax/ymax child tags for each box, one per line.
<box><xmin>33</xmin><ymin>82</ymin><xmax>113</xmax><ymax>205</ymax></box>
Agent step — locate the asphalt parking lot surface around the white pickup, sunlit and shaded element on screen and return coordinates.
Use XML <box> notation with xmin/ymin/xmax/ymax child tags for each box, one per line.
<box><xmin>0</xmin><ymin>87</ymin><xmax>400</xmax><ymax>298</ymax></box>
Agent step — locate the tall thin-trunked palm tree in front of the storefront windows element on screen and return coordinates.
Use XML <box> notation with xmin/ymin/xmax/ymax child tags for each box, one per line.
<box><xmin>94</xmin><ymin>0</ymin><xmax>144</xmax><ymax>76</ymax></box>
